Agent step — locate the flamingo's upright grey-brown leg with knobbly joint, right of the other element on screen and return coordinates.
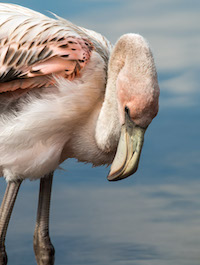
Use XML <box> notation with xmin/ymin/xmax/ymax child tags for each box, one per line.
<box><xmin>33</xmin><ymin>173</ymin><xmax>55</xmax><ymax>265</ymax></box>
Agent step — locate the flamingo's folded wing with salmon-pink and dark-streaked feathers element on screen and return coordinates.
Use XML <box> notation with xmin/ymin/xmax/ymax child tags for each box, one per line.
<box><xmin>0</xmin><ymin>4</ymin><xmax>93</xmax><ymax>93</ymax></box>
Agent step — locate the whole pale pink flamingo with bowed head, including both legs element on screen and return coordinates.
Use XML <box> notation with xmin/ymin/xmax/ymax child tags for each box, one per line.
<box><xmin>0</xmin><ymin>3</ymin><xmax>159</xmax><ymax>265</ymax></box>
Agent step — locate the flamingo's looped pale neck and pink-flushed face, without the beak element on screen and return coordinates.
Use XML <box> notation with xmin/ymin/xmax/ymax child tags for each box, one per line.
<box><xmin>96</xmin><ymin>34</ymin><xmax>159</xmax><ymax>151</ymax></box>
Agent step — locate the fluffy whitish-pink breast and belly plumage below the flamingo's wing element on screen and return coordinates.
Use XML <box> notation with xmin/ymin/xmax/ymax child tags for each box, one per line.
<box><xmin>0</xmin><ymin>50</ymin><xmax>107</xmax><ymax>181</ymax></box>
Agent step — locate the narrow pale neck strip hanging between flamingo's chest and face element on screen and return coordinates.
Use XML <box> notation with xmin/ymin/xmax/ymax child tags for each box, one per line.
<box><xmin>95</xmin><ymin>39</ymin><xmax>124</xmax><ymax>152</ymax></box>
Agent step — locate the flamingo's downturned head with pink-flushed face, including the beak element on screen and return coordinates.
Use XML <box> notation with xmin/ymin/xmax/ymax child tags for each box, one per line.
<box><xmin>108</xmin><ymin>34</ymin><xmax>159</xmax><ymax>181</ymax></box>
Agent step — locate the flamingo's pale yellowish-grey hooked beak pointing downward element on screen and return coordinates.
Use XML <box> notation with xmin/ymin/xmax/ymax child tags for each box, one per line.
<box><xmin>107</xmin><ymin>110</ymin><xmax>146</xmax><ymax>181</ymax></box>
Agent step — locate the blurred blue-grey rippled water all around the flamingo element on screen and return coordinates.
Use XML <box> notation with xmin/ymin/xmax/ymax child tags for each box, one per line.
<box><xmin>0</xmin><ymin>0</ymin><xmax>200</xmax><ymax>265</ymax></box>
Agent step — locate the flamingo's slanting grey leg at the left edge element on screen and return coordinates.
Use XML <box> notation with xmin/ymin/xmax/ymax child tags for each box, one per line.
<box><xmin>0</xmin><ymin>180</ymin><xmax>22</xmax><ymax>265</ymax></box>
